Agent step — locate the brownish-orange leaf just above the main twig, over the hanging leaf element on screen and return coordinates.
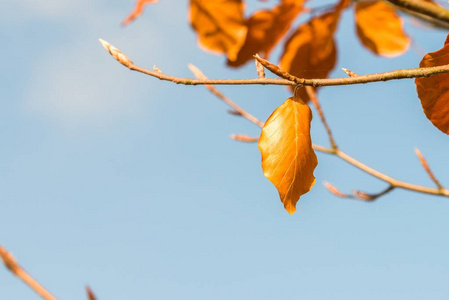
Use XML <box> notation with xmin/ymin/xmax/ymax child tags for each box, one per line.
<box><xmin>279</xmin><ymin>10</ymin><xmax>340</xmax><ymax>102</ymax></box>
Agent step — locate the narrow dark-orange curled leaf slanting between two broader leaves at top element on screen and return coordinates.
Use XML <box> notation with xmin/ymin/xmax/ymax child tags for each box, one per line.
<box><xmin>228</xmin><ymin>0</ymin><xmax>304</xmax><ymax>67</ymax></box>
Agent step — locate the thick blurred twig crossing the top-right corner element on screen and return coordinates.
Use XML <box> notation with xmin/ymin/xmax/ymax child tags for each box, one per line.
<box><xmin>386</xmin><ymin>0</ymin><xmax>449</xmax><ymax>24</ymax></box>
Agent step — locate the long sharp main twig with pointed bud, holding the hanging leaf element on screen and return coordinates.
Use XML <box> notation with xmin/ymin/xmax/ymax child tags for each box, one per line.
<box><xmin>100</xmin><ymin>39</ymin><xmax>449</xmax><ymax>87</ymax></box>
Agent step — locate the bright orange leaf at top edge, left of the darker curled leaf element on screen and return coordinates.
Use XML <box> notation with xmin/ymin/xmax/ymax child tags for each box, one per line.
<box><xmin>189</xmin><ymin>0</ymin><xmax>247</xmax><ymax>61</ymax></box>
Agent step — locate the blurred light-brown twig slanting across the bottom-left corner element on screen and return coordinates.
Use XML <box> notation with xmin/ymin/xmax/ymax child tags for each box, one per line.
<box><xmin>0</xmin><ymin>246</ymin><xmax>56</xmax><ymax>300</ymax></box>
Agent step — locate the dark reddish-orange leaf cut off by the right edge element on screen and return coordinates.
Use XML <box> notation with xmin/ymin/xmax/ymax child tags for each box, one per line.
<box><xmin>415</xmin><ymin>35</ymin><xmax>449</xmax><ymax>134</ymax></box>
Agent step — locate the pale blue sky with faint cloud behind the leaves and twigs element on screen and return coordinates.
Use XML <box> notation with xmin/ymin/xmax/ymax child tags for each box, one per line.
<box><xmin>0</xmin><ymin>0</ymin><xmax>449</xmax><ymax>300</ymax></box>
